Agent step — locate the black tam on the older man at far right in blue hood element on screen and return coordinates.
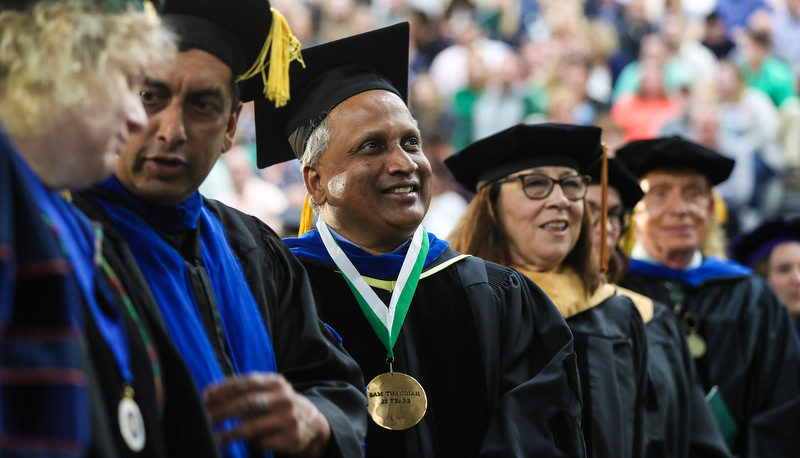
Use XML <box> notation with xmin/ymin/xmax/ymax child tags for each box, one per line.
<box><xmin>617</xmin><ymin>136</ymin><xmax>735</xmax><ymax>186</ymax></box>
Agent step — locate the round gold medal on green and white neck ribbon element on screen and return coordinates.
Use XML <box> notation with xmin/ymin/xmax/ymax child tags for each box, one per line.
<box><xmin>317</xmin><ymin>218</ymin><xmax>430</xmax><ymax>430</ymax></box>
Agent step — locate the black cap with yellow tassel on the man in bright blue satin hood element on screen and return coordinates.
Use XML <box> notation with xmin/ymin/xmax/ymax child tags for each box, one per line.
<box><xmin>161</xmin><ymin>0</ymin><xmax>299</xmax><ymax>102</ymax></box>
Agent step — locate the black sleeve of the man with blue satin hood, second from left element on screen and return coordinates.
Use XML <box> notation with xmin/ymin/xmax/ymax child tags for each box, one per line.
<box><xmin>206</xmin><ymin>200</ymin><xmax>367</xmax><ymax>457</ymax></box>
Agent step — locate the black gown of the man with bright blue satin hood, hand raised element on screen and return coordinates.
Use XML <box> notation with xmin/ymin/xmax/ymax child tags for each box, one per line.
<box><xmin>75</xmin><ymin>188</ymin><xmax>366</xmax><ymax>457</ymax></box>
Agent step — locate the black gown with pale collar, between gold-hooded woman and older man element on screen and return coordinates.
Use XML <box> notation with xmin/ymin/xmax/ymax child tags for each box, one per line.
<box><xmin>617</xmin><ymin>287</ymin><xmax>730</xmax><ymax>458</ymax></box>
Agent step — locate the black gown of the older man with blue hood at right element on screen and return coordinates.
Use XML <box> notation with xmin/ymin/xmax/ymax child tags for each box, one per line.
<box><xmin>621</xmin><ymin>273</ymin><xmax>800</xmax><ymax>458</ymax></box>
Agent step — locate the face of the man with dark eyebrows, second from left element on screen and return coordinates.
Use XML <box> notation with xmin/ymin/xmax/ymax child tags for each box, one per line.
<box><xmin>115</xmin><ymin>49</ymin><xmax>241</xmax><ymax>205</ymax></box>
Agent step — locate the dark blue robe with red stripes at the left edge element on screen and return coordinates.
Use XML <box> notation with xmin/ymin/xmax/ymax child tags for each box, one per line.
<box><xmin>0</xmin><ymin>127</ymin><xmax>92</xmax><ymax>458</ymax></box>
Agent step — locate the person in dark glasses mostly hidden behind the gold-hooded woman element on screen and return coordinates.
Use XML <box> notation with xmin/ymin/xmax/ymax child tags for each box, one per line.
<box><xmin>586</xmin><ymin>159</ymin><xmax>730</xmax><ymax>458</ymax></box>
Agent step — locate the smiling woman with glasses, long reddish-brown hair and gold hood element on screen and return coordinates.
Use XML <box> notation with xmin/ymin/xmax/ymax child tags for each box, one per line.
<box><xmin>445</xmin><ymin>124</ymin><xmax>647</xmax><ymax>458</ymax></box>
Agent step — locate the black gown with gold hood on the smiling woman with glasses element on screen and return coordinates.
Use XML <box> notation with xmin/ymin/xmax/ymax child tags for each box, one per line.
<box><xmin>521</xmin><ymin>269</ymin><xmax>647</xmax><ymax>458</ymax></box>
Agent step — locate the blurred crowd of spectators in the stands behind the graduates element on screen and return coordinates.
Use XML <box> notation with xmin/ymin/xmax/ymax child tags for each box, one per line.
<box><xmin>201</xmin><ymin>0</ymin><xmax>800</xmax><ymax>242</ymax></box>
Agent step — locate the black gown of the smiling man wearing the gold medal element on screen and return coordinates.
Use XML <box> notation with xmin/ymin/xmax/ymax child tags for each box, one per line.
<box><xmin>294</xmin><ymin>249</ymin><xmax>585</xmax><ymax>458</ymax></box>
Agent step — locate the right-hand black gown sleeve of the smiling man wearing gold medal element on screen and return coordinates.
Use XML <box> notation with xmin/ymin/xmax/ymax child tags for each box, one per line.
<box><xmin>457</xmin><ymin>258</ymin><xmax>586</xmax><ymax>457</ymax></box>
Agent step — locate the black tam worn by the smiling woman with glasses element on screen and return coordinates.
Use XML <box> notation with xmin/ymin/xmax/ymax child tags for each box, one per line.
<box><xmin>444</xmin><ymin>123</ymin><xmax>603</xmax><ymax>191</ymax></box>
